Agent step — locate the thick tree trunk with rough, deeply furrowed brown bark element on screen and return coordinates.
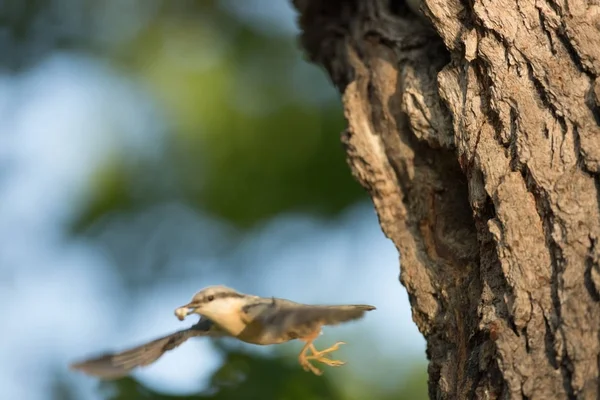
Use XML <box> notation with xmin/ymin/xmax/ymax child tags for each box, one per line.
<box><xmin>293</xmin><ymin>0</ymin><xmax>600</xmax><ymax>399</ymax></box>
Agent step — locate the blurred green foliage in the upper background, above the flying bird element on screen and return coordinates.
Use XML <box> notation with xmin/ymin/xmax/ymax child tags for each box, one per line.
<box><xmin>65</xmin><ymin>2</ymin><xmax>366</xmax><ymax>228</ymax></box>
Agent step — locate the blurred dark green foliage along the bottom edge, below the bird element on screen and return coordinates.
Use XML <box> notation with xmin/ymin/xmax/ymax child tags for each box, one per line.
<box><xmin>101</xmin><ymin>349</ymin><xmax>427</xmax><ymax>400</ymax></box>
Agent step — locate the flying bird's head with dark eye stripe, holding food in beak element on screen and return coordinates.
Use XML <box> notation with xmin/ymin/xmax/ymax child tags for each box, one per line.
<box><xmin>175</xmin><ymin>285</ymin><xmax>248</xmax><ymax>321</ymax></box>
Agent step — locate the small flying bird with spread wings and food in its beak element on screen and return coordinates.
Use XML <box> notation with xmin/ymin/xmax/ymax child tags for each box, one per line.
<box><xmin>70</xmin><ymin>285</ymin><xmax>376</xmax><ymax>380</ymax></box>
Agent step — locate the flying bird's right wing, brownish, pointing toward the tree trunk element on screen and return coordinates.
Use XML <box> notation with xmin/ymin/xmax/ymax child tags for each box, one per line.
<box><xmin>244</xmin><ymin>298</ymin><xmax>375</xmax><ymax>339</ymax></box>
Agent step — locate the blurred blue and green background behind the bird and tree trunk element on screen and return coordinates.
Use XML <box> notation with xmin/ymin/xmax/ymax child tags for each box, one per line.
<box><xmin>0</xmin><ymin>0</ymin><xmax>426</xmax><ymax>400</ymax></box>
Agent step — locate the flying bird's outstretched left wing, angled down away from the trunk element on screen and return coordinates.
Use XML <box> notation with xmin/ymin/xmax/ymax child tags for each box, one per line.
<box><xmin>71</xmin><ymin>319</ymin><xmax>223</xmax><ymax>379</ymax></box>
